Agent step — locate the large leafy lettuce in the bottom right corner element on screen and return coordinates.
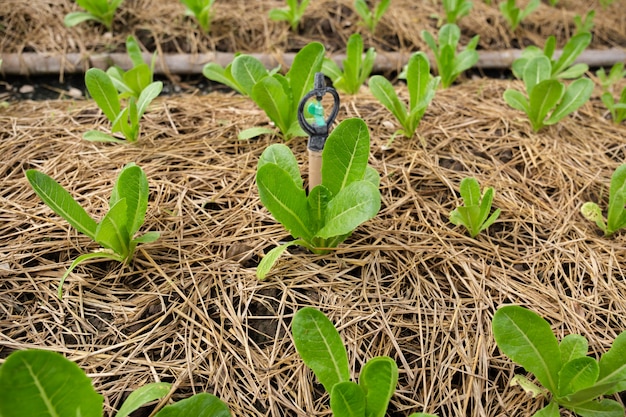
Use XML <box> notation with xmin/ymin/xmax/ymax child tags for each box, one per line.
<box><xmin>492</xmin><ymin>305</ymin><xmax>626</xmax><ymax>417</ymax></box>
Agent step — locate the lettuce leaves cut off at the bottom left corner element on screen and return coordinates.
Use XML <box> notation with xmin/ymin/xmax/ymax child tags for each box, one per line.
<box><xmin>0</xmin><ymin>350</ymin><xmax>230</xmax><ymax>417</ymax></box>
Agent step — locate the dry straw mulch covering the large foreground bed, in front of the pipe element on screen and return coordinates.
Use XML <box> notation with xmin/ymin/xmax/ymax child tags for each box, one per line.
<box><xmin>0</xmin><ymin>80</ymin><xmax>626</xmax><ymax>417</ymax></box>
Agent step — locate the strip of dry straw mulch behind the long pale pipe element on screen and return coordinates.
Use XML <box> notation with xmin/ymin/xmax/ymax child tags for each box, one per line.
<box><xmin>0</xmin><ymin>0</ymin><xmax>626</xmax><ymax>55</ymax></box>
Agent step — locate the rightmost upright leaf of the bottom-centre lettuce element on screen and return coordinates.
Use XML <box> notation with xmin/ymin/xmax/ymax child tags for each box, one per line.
<box><xmin>359</xmin><ymin>356</ymin><xmax>398</xmax><ymax>417</ymax></box>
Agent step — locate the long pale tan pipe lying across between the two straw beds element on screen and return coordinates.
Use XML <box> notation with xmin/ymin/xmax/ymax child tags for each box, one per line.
<box><xmin>0</xmin><ymin>48</ymin><xmax>626</xmax><ymax>76</ymax></box>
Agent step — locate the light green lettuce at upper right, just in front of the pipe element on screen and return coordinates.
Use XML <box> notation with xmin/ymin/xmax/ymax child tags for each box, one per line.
<box><xmin>504</xmin><ymin>56</ymin><xmax>593</xmax><ymax>132</ymax></box>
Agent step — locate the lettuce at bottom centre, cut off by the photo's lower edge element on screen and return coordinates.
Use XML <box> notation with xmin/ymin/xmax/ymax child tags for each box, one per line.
<box><xmin>291</xmin><ymin>307</ymin><xmax>398</xmax><ymax>417</ymax></box>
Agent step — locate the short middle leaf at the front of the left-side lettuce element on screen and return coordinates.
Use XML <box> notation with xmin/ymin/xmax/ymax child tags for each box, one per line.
<box><xmin>96</xmin><ymin>198</ymin><xmax>130</xmax><ymax>260</ymax></box>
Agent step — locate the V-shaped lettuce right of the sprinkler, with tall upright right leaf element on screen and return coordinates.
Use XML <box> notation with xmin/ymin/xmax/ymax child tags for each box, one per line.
<box><xmin>369</xmin><ymin>52</ymin><xmax>441</xmax><ymax>138</ymax></box>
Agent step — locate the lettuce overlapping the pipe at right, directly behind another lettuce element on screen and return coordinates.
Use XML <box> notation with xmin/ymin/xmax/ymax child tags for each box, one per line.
<box><xmin>512</xmin><ymin>32</ymin><xmax>591</xmax><ymax>80</ymax></box>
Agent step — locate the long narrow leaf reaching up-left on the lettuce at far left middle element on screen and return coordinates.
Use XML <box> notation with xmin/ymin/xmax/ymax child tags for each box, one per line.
<box><xmin>26</xmin><ymin>169</ymin><xmax>98</xmax><ymax>240</ymax></box>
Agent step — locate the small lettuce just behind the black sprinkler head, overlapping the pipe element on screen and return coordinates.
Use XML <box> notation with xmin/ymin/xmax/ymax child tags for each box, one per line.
<box><xmin>322</xmin><ymin>33</ymin><xmax>376</xmax><ymax>94</ymax></box>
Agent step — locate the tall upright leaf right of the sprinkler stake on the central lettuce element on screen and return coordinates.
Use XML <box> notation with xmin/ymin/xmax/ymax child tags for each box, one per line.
<box><xmin>322</xmin><ymin>118</ymin><xmax>370</xmax><ymax>195</ymax></box>
